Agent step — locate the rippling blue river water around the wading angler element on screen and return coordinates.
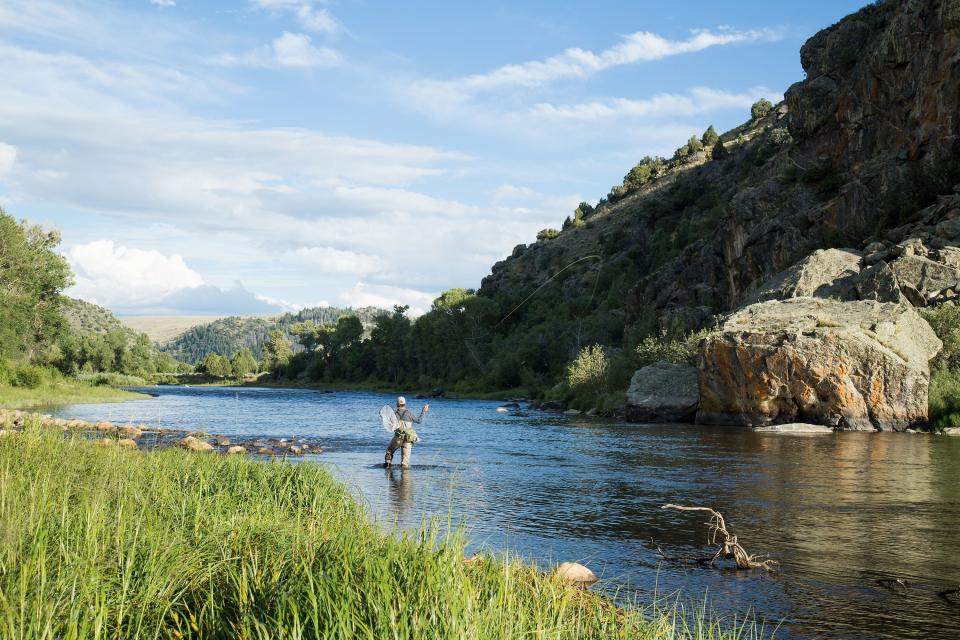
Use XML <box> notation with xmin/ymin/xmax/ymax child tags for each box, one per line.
<box><xmin>50</xmin><ymin>387</ymin><xmax>960</xmax><ymax>640</ymax></box>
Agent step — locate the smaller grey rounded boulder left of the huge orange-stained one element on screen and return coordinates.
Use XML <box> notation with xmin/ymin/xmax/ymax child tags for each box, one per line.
<box><xmin>626</xmin><ymin>362</ymin><xmax>700</xmax><ymax>422</ymax></box>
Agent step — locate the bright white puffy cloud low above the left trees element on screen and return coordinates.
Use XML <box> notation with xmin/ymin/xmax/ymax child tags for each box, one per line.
<box><xmin>67</xmin><ymin>240</ymin><xmax>203</xmax><ymax>307</ymax></box>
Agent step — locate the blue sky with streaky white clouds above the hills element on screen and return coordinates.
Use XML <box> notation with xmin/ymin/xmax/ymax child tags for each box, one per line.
<box><xmin>0</xmin><ymin>0</ymin><xmax>864</xmax><ymax>314</ymax></box>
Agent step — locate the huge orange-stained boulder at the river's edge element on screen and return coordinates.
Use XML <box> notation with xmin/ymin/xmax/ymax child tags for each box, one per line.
<box><xmin>697</xmin><ymin>298</ymin><xmax>942</xmax><ymax>431</ymax></box>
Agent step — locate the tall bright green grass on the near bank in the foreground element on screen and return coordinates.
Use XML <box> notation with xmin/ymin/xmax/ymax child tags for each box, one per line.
<box><xmin>0</xmin><ymin>424</ymin><xmax>764</xmax><ymax>640</ymax></box>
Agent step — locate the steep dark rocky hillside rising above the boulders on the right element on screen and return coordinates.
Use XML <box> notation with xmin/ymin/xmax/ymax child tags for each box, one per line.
<box><xmin>480</xmin><ymin>0</ymin><xmax>960</xmax><ymax>344</ymax></box>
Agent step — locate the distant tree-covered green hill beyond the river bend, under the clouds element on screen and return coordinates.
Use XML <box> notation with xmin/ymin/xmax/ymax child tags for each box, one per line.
<box><xmin>160</xmin><ymin>307</ymin><xmax>384</xmax><ymax>364</ymax></box>
